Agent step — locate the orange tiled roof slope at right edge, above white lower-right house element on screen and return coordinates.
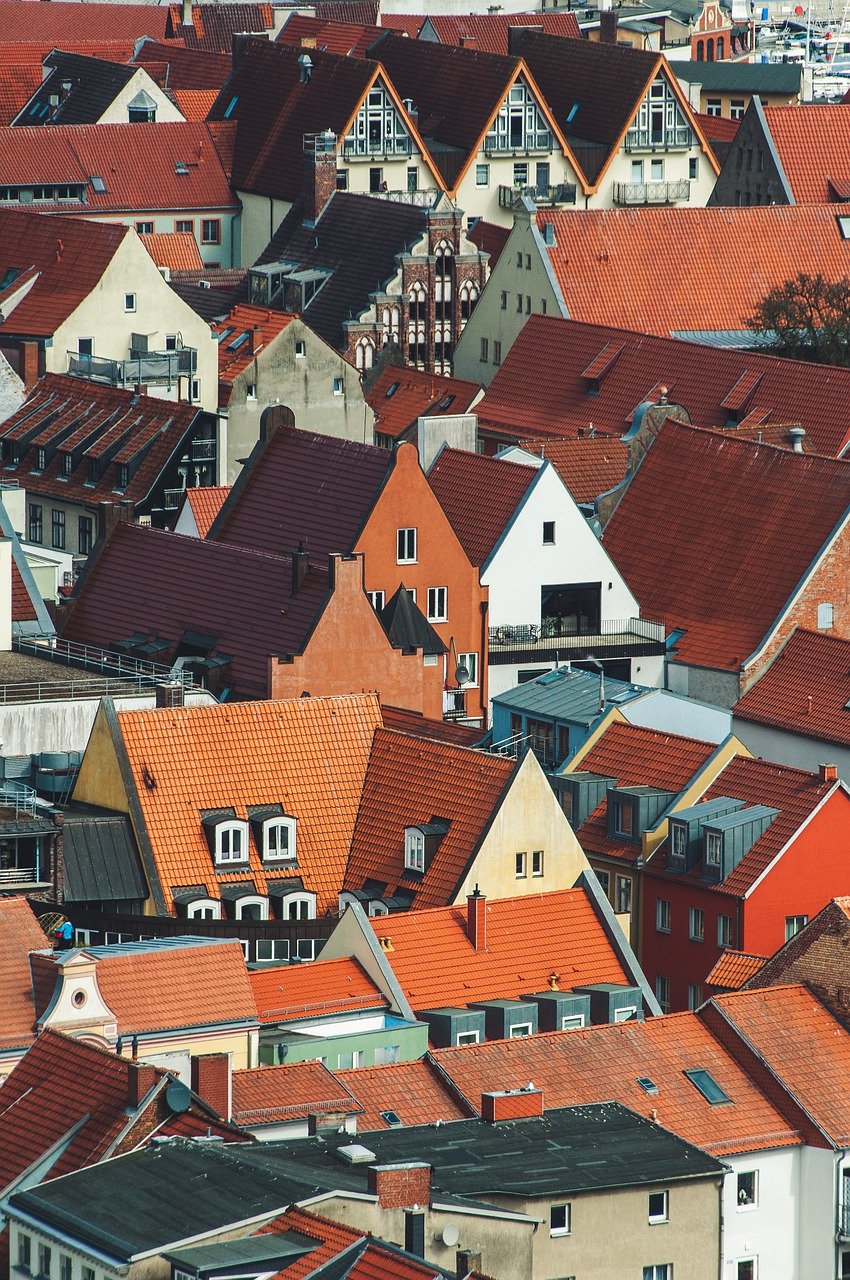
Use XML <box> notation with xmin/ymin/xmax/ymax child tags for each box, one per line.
<box><xmin>713</xmin><ymin>986</ymin><xmax>850</xmax><ymax>1147</ymax></box>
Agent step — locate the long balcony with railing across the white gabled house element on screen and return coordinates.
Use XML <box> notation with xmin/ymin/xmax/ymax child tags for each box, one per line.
<box><xmin>490</xmin><ymin>617</ymin><xmax>664</xmax><ymax>664</ymax></box>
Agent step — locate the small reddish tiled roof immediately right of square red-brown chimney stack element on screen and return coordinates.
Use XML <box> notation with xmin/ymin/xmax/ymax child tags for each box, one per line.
<box><xmin>232</xmin><ymin>1054</ymin><xmax>358</xmax><ymax>1126</ymax></box>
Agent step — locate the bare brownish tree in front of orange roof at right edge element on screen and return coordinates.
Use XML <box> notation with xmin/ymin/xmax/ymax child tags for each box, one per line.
<box><xmin>744</xmin><ymin>271</ymin><xmax>850</xmax><ymax>365</ymax></box>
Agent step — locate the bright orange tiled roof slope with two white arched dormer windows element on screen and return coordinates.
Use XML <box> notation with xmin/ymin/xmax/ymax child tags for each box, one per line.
<box><xmin>118</xmin><ymin>696</ymin><xmax>387</xmax><ymax>915</ymax></box>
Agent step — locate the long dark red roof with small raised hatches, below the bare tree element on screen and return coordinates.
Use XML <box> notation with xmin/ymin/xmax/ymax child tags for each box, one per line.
<box><xmin>475</xmin><ymin>315</ymin><xmax>850</xmax><ymax>457</ymax></box>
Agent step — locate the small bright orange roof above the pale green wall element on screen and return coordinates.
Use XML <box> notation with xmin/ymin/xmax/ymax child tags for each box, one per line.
<box><xmin>248</xmin><ymin>957</ymin><xmax>389</xmax><ymax>1024</ymax></box>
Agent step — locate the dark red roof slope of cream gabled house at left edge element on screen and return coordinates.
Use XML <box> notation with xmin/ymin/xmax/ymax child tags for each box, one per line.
<box><xmin>0</xmin><ymin>207</ymin><xmax>128</xmax><ymax>339</ymax></box>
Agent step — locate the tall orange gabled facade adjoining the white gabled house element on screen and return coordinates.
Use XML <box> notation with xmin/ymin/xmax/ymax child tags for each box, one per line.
<box><xmin>356</xmin><ymin>444</ymin><xmax>488</xmax><ymax>723</ymax></box>
